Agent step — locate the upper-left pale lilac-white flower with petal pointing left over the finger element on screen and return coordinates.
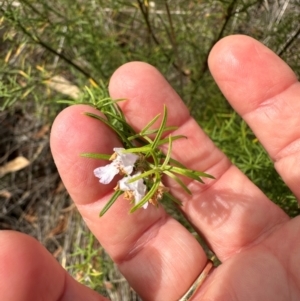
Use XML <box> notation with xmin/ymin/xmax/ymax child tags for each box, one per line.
<box><xmin>94</xmin><ymin>147</ymin><xmax>139</xmax><ymax>184</ymax></box>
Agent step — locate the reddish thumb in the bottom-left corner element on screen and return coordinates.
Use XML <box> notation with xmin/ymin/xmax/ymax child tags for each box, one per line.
<box><xmin>0</xmin><ymin>231</ymin><xmax>107</xmax><ymax>301</ymax></box>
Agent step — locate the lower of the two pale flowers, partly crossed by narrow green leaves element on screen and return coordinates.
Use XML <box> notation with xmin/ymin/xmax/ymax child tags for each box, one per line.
<box><xmin>119</xmin><ymin>172</ymin><xmax>148</xmax><ymax>209</ymax></box>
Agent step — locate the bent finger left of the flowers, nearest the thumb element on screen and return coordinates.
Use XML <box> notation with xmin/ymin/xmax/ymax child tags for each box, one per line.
<box><xmin>51</xmin><ymin>105</ymin><xmax>206</xmax><ymax>300</ymax></box>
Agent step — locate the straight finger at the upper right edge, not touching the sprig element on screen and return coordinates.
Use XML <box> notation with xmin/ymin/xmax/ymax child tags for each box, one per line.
<box><xmin>209</xmin><ymin>36</ymin><xmax>300</xmax><ymax>199</ymax></box>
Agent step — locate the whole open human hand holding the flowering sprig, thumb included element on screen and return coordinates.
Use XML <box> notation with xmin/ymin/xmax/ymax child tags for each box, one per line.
<box><xmin>0</xmin><ymin>36</ymin><xmax>300</xmax><ymax>301</ymax></box>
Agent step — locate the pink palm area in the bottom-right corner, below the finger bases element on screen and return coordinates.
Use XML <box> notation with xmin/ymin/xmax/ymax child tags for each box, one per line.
<box><xmin>209</xmin><ymin>218</ymin><xmax>300</xmax><ymax>301</ymax></box>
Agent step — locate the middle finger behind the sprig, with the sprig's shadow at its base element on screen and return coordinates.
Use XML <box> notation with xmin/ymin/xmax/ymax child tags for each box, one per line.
<box><xmin>109</xmin><ymin>63</ymin><xmax>287</xmax><ymax>260</ymax></box>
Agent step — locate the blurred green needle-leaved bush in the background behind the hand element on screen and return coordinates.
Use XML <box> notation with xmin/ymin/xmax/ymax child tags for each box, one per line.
<box><xmin>0</xmin><ymin>0</ymin><xmax>300</xmax><ymax>300</ymax></box>
